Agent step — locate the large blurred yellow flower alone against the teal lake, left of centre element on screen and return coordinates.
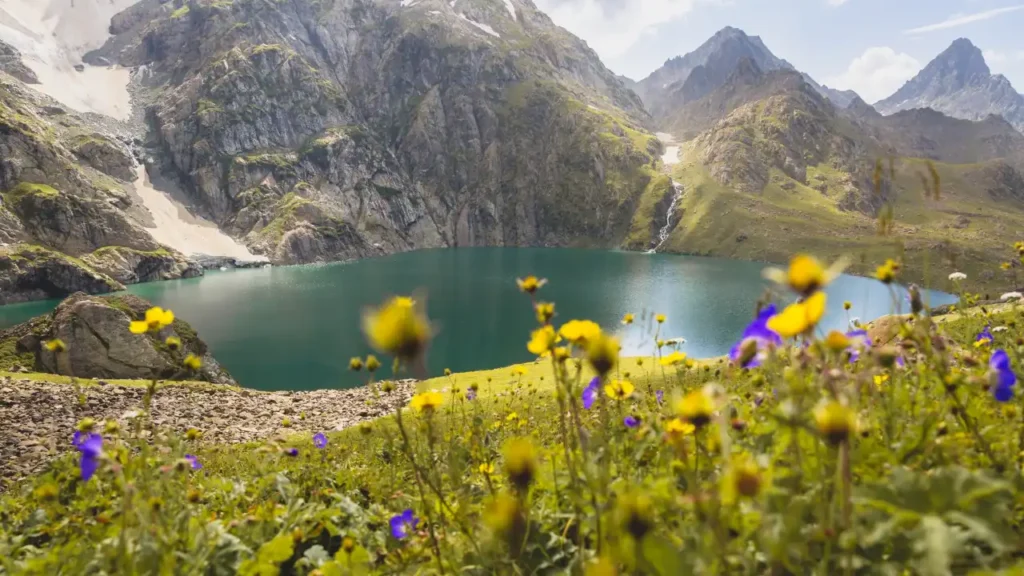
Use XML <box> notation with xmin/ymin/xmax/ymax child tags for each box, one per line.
<box><xmin>362</xmin><ymin>296</ymin><xmax>431</xmax><ymax>360</ymax></box>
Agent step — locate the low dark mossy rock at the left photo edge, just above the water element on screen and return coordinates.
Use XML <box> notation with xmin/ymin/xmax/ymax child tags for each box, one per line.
<box><xmin>0</xmin><ymin>245</ymin><xmax>124</xmax><ymax>304</ymax></box>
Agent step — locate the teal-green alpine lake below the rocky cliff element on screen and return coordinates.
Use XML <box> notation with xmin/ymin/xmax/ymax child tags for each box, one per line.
<box><xmin>0</xmin><ymin>248</ymin><xmax>956</xmax><ymax>390</ymax></box>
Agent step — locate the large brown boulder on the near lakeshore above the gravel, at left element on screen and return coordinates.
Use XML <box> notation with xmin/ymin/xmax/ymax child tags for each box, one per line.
<box><xmin>9</xmin><ymin>293</ymin><xmax>234</xmax><ymax>384</ymax></box>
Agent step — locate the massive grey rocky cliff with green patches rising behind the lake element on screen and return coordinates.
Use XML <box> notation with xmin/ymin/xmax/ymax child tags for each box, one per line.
<box><xmin>88</xmin><ymin>0</ymin><xmax>659</xmax><ymax>263</ymax></box>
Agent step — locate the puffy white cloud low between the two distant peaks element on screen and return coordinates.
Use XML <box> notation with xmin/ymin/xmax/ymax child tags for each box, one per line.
<box><xmin>825</xmin><ymin>46</ymin><xmax>922</xmax><ymax>102</ymax></box>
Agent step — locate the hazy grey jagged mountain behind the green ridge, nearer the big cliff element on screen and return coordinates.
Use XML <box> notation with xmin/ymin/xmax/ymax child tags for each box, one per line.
<box><xmin>634</xmin><ymin>27</ymin><xmax>856</xmax><ymax>118</ymax></box>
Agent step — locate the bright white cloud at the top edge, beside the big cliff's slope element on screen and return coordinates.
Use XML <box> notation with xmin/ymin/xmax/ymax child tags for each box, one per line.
<box><xmin>537</xmin><ymin>0</ymin><xmax>706</xmax><ymax>61</ymax></box>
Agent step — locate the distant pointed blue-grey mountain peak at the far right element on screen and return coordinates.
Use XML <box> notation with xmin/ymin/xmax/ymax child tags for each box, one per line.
<box><xmin>874</xmin><ymin>38</ymin><xmax>1024</xmax><ymax>130</ymax></box>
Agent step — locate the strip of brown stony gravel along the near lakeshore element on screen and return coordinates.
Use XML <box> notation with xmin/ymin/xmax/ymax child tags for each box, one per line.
<box><xmin>0</xmin><ymin>376</ymin><xmax>416</xmax><ymax>483</ymax></box>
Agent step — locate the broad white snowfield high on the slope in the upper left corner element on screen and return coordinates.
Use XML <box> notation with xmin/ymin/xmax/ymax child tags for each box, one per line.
<box><xmin>0</xmin><ymin>0</ymin><xmax>137</xmax><ymax>120</ymax></box>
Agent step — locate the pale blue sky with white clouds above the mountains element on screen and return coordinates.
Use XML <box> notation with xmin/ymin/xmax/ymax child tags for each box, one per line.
<box><xmin>535</xmin><ymin>0</ymin><xmax>1024</xmax><ymax>102</ymax></box>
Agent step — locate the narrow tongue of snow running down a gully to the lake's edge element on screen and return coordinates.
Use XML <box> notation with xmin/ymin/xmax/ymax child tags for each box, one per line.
<box><xmin>135</xmin><ymin>165</ymin><xmax>266</xmax><ymax>261</ymax></box>
